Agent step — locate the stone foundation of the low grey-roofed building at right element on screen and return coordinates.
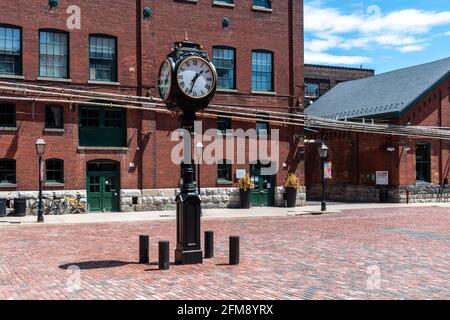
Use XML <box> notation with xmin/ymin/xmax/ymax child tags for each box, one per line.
<box><xmin>306</xmin><ymin>184</ymin><xmax>450</xmax><ymax>203</ymax></box>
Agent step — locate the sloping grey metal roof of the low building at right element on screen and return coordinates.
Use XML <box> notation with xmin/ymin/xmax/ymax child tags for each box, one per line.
<box><xmin>305</xmin><ymin>57</ymin><xmax>450</xmax><ymax>119</ymax></box>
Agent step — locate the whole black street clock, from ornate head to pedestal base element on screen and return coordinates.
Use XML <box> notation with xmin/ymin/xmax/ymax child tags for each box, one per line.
<box><xmin>158</xmin><ymin>39</ymin><xmax>217</xmax><ymax>264</ymax></box>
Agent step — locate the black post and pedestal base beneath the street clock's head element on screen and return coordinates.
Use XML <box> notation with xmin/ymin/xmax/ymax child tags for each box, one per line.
<box><xmin>175</xmin><ymin>113</ymin><xmax>203</xmax><ymax>265</ymax></box>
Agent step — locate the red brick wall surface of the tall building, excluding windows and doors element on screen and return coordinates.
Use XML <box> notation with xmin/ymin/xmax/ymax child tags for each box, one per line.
<box><xmin>0</xmin><ymin>0</ymin><xmax>303</xmax><ymax>190</ymax></box>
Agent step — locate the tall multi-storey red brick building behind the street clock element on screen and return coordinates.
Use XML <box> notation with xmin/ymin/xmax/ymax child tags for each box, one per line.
<box><xmin>0</xmin><ymin>0</ymin><xmax>304</xmax><ymax>211</ymax></box>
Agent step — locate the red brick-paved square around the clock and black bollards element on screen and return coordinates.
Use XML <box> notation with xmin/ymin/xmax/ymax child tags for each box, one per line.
<box><xmin>0</xmin><ymin>208</ymin><xmax>450</xmax><ymax>299</ymax></box>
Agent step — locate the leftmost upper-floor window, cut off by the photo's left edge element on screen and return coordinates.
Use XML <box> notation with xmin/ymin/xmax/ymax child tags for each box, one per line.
<box><xmin>0</xmin><ymin>25</ymin><xmax>22</xmax><ymax>75</ymax></box>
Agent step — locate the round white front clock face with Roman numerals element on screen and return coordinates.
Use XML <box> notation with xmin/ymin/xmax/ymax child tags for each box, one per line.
<box><xmin>177</xmin><ymin>57</ymin><xmax>216</xmax><ymax>99</ymax></box>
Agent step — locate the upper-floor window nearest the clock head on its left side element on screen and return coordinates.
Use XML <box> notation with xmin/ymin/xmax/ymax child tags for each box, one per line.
<box><xmin>89</xmin><ymin>35</ymin><xmax>117</xmax><ymax>82</ymax></box>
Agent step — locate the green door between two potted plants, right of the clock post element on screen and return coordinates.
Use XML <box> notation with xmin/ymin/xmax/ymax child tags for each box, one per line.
<box><xmin>250</xmin><ymin>163</ymin><xmax>275</xmax><ymax>207</ymax></box>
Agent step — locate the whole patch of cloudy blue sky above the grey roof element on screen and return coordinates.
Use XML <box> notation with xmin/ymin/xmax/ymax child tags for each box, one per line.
<box><xmin>305</xmin><ymin>0</ymin><xmax>450</xmax><ymax>73</ymax></box>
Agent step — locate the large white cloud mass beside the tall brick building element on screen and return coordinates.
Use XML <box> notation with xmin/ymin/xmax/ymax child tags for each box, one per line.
<box><xmin>305</xmin><ymin>1</ymin><xmax>450</xmax><ymax>64</ymax></box>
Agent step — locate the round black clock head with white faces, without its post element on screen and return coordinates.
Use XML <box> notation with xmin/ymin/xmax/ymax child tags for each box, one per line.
<box><xmin>158</xmin><ymin>41</ymin><xmax>217</xmax><ymax>114</ymax></box>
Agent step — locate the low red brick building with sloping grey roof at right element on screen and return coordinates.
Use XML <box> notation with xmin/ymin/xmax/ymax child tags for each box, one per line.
<box><xmin>305</xmin><ymin>58</ymin><xmax>450</xmax><ymax>202</ymax></box>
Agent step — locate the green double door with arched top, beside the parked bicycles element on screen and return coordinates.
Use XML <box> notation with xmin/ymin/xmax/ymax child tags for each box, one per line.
<box><xmin>86</xmin><ymin>162</ymin><xmax>120</xmax><ymax>211</ymax></box>
